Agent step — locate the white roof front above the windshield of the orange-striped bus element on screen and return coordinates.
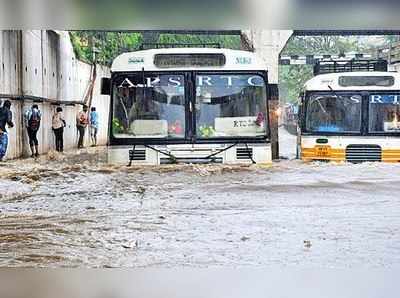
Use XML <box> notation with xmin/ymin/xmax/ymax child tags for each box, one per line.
<box><xmin>304</xmin><ymin>71</ymin><xmax>400</xmax><ymax>91</ymax></box>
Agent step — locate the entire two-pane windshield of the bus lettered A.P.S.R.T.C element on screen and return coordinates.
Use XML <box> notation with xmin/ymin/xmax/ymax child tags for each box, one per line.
<box><xmin>112</xmin><ymin>72</ymin><xmax>268</xmax><ymax>139</ymax></box>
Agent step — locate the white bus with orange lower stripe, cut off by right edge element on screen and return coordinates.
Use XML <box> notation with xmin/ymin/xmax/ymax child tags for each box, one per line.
<box><xmin>298</xmin><ymin>71</ymin><xmax>400</xmax><ymax>162</ymax></box>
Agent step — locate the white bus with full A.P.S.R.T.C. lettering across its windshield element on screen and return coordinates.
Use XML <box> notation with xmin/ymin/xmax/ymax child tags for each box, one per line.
<box><xmin>102</xmin><ymin>48</ymin><xmax>272</xmax><ymax>165</ymax></box>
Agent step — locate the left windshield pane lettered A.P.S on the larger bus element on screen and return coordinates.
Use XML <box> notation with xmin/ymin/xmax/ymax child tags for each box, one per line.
<box><xmin>112</xmin><ymin>73</ymin><xmax>185</xmax><ymax>138</ymax></box>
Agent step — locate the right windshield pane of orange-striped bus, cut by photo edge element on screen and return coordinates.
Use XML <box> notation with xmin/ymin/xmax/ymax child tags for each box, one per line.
<box><xmin>369</xmin><ymin>94</ymin><xmax>400</xmax><ymax>133</ymax></box>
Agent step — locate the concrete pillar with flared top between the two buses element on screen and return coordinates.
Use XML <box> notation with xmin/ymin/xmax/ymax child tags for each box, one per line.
<box><xmin>242</xmin><ymin>29</ymin><xmax>293</xmax><ymax>159</ymax></box>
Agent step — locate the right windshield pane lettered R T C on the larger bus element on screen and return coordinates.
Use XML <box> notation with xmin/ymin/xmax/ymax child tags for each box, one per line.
<box><xmin>196</xmin><ymin>74</ymin><xmax>267</xmax><ymax>138</ymax></box>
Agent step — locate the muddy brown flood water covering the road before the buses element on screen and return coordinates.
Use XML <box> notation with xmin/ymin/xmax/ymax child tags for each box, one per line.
<box><xmin>0</xmin><ymin>130</ymin><xmax>400</xmax><ymax>268</ymax></box>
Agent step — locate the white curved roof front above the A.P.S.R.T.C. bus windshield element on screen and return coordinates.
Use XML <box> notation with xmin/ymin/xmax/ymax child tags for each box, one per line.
<box><xmin>111</xmin><ymin>48</ymin><xmax>266</xmax><ymax>72</ymax></box>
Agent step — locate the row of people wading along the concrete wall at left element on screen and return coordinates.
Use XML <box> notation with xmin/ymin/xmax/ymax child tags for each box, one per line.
<box><xmin>0</xmin><ymin>100</ymin><xmax>99</xmax><ymax>161</ymax></box>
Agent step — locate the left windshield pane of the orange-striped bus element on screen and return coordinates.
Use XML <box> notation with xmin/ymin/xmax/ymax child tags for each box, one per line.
<box><xmin>306</xmin><ymin>93</ymin><xmax>362</xmax><ymax>133</ymax></box>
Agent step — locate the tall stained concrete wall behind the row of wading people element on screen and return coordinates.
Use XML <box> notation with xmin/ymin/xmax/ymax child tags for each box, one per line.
<box><xmin>0</xmin><ymin>30</ymin><xmax>109</xmax><ymax>158</ymax></box>
